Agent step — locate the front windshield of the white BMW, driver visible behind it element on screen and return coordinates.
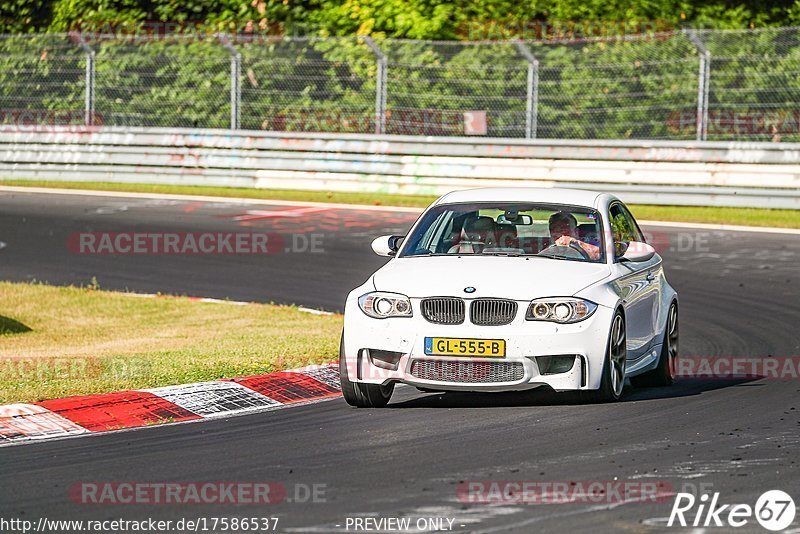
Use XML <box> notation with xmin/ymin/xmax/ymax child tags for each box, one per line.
<box><xmin>400</xmin><ymin>202</ymin><xmax>605</xmax><ymax>262</ymax></box>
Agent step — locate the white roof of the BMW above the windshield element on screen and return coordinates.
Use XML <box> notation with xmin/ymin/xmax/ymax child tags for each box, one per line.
<box><xmin>436</xmin><ymin>187</ymin><xmax>610</xmax><ymax>208</ymax></box>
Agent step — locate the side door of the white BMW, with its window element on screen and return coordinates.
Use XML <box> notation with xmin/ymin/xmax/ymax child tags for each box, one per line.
<box><xmin>609</xmin><ymin>202</ymin><xmax>661</xmax><ymax>360</ymax></box>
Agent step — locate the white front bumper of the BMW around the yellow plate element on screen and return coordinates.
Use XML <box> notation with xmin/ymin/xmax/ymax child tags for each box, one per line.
<box><xmin>344</xmin><ymin>294</ymin><xmax>613</xmax><ymax>391</ymax></box>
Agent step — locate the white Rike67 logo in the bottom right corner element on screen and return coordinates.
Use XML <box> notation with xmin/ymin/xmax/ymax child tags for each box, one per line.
<box><xmin>667</xmin><ymin>490</ymin><xmax>796</xmax><ymax>532</ymax></box>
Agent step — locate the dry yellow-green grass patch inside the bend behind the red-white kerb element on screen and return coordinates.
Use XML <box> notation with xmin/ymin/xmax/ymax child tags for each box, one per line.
<box><xmin>0</xmin><ymin>282</ymin><xmax>342</xmax><ymax>404</ymax></box>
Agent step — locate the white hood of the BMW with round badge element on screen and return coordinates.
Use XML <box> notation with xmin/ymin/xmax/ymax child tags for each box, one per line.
<box><xmin>373</xmin><ymin>256</ymin><xmax>611</xmax><ymax>300</ymax></box>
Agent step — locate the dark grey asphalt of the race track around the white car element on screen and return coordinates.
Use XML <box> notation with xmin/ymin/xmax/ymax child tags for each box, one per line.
<box><xmin>0</xmin><ymin>193</ymin><xmax>800</xmax><ymax>532</ymax></box>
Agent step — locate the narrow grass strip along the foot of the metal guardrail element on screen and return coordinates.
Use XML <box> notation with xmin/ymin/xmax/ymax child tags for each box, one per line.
<box><xmin>0</xmin><ymin>180</ymin><xmax>800</xmax><ymax>228</ymax></box>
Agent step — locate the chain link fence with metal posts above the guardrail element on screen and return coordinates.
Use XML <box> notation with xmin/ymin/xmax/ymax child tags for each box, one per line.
<box><xmin>0</xmin><ymin>28</ymin><xmax>800</xmax><ymax>142</ymax></box>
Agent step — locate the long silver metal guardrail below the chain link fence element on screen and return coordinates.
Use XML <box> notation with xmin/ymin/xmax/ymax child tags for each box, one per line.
<box><xmin>0</xmin><ymin>127</ymin><xmax>800</xmax><ymax>209</ymax></box>
